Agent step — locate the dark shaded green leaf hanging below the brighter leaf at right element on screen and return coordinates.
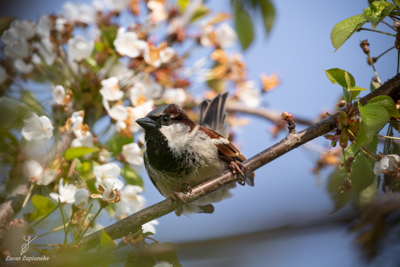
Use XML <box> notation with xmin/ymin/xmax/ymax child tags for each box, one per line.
<box><xmin>346</xmin><ymin>136</ymin><xmax>378</xmax><ymax>192</ymax></box>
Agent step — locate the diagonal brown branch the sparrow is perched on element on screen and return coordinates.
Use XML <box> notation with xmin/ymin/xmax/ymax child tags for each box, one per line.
<box><xmin>78</xmin><ymin>74</ymin><xmax>400</xmax><ymax>250</ymax></box>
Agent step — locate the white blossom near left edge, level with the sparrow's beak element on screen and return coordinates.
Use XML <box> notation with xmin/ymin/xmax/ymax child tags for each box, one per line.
<box><xmin>22</xmin><ymin>113</ymin><xmax>54</xmax><ymax>141</ymax></box>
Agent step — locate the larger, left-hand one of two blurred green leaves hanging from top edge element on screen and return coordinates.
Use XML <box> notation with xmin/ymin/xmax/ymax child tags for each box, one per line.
<box><xmin>235</xmin><ymin>1</ymin><xmax>254</xmax><ymax>50</ymax></box>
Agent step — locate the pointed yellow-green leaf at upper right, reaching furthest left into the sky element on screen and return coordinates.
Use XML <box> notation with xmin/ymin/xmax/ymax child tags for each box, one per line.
<box><xmin>331</xmin><ymin>14</ymin><xmax>367</xmax><ymax>52</ymax></box>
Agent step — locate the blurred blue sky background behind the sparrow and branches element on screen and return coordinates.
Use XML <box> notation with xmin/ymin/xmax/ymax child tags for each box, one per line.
<box><xmin>0</xmin><ymin>0</ymin><xmax>398</xmax><ymax>267</ymax></box>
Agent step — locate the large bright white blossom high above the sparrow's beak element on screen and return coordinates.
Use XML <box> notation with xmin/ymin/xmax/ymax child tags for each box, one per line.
<box><xmin>114</xmin><ymin>27</ymin><xmax>148</xmax><ymax>58</ymax></box>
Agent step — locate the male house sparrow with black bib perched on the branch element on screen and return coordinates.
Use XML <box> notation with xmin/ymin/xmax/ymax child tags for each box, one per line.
<box><xmin>136</xmin><ymin>93</ymin><xmax>254</xmax><ymax>216</ymax></box>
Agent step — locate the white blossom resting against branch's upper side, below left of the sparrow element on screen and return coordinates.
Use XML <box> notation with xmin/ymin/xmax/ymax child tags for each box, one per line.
<box><xmin>115</xmin><ymin>185</ymin><xmax>146</xmax><ymax>217</ymax></box>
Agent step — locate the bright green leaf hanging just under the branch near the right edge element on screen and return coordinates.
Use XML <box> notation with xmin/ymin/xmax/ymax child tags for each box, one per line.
<box><xmin>358</xmin><ymin>102</ymin><xmax>390</xmax><ymax>137</ymax></box>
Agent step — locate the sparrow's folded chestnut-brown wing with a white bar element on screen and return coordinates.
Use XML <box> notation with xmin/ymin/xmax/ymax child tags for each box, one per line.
<box><xmin>200</xmin><ymin>126</ymin><xmax>246</xmax><ymax>163</ymax></box>
